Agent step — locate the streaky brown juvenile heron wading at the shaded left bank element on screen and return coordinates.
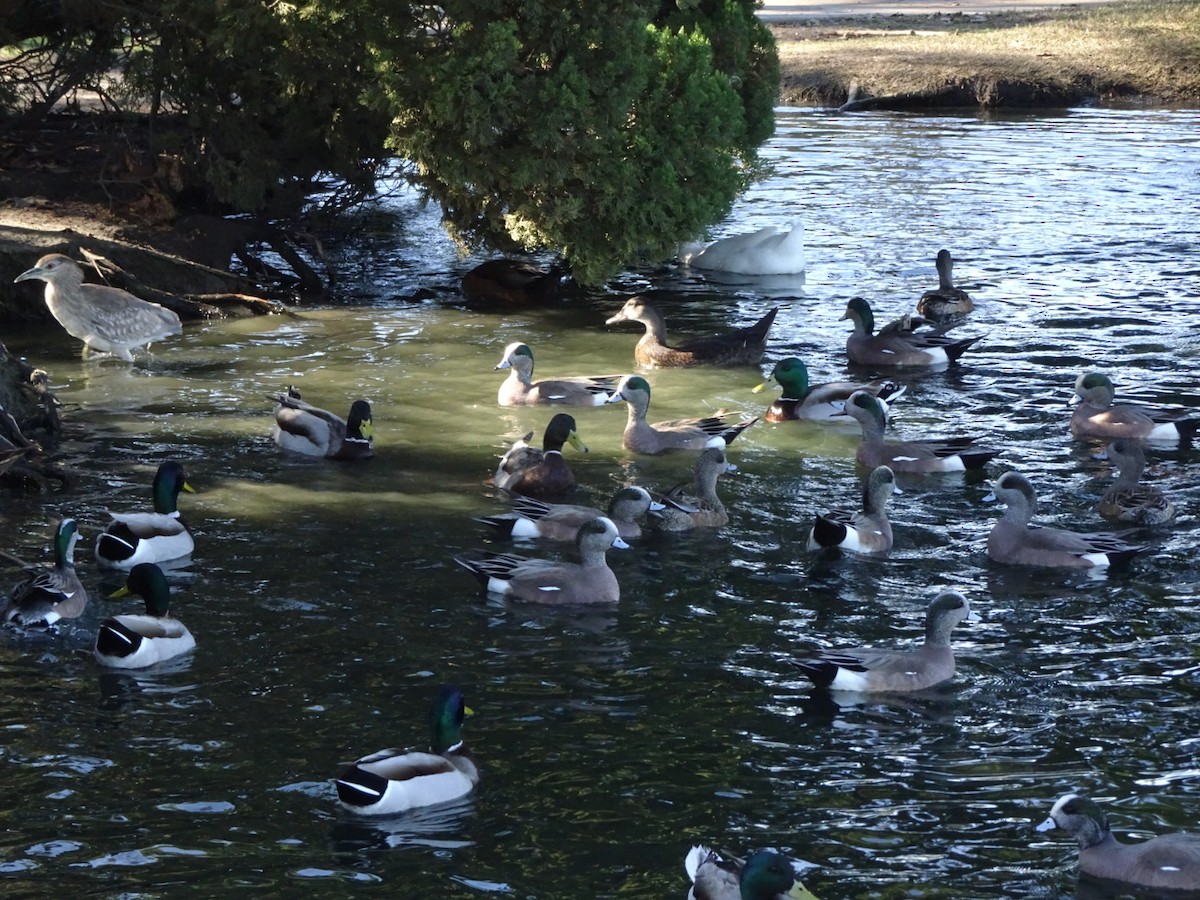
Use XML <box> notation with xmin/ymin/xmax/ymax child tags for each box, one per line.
<box><xmin>14</xmin><ymin>253</ymin><xmax>184</xmax><ymax>362</ymax></box>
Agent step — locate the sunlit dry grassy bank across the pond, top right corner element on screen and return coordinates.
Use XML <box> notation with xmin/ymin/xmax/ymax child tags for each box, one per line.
<box><xmin>772</xmin><ymin>0</ymin><xmax>1200</xmax><ymax>108</ymax></box>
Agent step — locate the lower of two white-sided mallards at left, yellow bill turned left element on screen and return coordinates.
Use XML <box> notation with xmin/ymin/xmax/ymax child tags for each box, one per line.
<box><xmin>94</xmin><ymin>563</ymin><xmax>196</xmax><ymax>668</ymax></box>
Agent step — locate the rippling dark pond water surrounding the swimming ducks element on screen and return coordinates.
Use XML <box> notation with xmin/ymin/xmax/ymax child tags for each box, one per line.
<box><xmin>0</xmin><ymin>109</ymin><xmax>1200</xmax><ymax>900</ymax></box>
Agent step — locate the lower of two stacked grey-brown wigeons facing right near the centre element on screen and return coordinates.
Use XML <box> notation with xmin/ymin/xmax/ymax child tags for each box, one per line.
<box><xmin>455</xmin><ymin>516</ymin><xmax>629</xmax><ymax>605</ymax></box>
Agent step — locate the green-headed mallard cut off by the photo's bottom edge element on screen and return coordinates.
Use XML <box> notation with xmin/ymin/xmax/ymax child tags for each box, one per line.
<box><xmin>683</xmin><ymin>844</ymin><xmax>817</xmax><ymax>900</ymax></box>
